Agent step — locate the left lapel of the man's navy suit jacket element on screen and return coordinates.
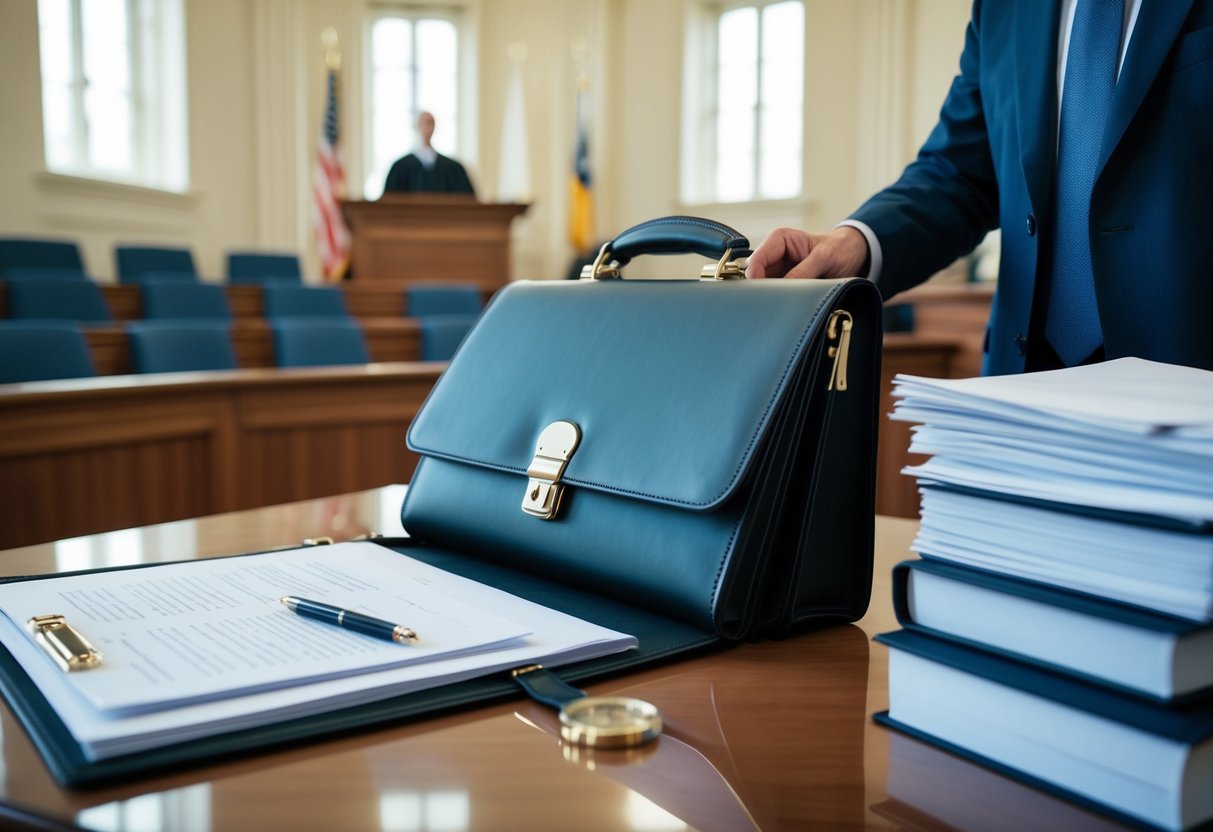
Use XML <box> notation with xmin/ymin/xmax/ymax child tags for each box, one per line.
<box><xmin>1014</xmin><ymin>0</ymin><xmax>1061</xmax><ymax>218</ymax></box>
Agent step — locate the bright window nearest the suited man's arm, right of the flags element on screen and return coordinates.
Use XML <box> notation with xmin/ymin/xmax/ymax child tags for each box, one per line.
<box><xmin>683</xmin><ymin>0</ymin><xmax>804</xmax><ymax>203</ymax></box>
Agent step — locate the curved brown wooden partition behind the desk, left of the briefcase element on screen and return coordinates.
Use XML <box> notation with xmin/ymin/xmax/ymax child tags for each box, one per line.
<box><xmin>0</xmin><ymin>364</ymin><xmax>445</xmax><ymax>548</ymax></box>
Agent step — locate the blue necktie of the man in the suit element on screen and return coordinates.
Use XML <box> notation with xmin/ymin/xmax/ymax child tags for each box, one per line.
<box><xmin>1044</xmin><ymin>0</ymin><xmax>1124</xmax><ymax>366</ymax></box>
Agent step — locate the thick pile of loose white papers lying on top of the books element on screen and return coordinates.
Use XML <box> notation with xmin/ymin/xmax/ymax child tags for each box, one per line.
<box><xmin>892</xmin><ymin>358</ymin><xmax>1213</xmax><ymax>621</ymax></box>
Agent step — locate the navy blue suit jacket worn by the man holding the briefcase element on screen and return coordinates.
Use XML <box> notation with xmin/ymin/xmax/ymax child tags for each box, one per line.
<box><xmin>853</xmin><ymin>0</ymin><xmax>1213</xmax><ymax>375</ymax></box>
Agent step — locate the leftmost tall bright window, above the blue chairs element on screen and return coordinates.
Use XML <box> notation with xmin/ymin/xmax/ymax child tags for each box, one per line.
<box><xmin>38</xmin><ymin>0</ymin><xmax>189</xmax><ymax>190</ymax></box>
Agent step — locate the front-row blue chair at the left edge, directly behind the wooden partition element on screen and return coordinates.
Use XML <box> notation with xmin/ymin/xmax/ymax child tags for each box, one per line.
<box><xmin>0</xmin><ymin>320</ymin><xmax>97</xmax><ymax>384</ymax></box>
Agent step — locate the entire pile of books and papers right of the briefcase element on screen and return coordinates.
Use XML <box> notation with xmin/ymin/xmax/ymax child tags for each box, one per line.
<box><xmin>877</xmin><ymin>359</ymin><xmax>1213</xmax><ymax>830</ymax></box>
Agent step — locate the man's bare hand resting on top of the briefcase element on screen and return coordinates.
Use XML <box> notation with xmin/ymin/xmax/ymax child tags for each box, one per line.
<box><xmin>746</xmin><ymin>226</ymin><xmax>867</xmax><ymax>279</ymax></box>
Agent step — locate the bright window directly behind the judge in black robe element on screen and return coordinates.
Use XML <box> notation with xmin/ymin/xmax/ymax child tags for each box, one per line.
<box><xmin>363</xmin><ymin>10</ymin><xmax>460</xmax><ymax>199</ymax></box>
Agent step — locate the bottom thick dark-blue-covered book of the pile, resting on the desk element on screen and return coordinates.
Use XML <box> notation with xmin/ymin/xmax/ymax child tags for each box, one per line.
<box><xmin>876</xmin><ymin>631</ymin><xmax>1213</xmax><ymax>830</ymax></box>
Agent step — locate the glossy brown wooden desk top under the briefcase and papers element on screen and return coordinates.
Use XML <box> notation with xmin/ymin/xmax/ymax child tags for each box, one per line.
<box><xmin>0</xmin><ymin>486</ymin><xmax>1118</xmax><ymax>832</ymax></box>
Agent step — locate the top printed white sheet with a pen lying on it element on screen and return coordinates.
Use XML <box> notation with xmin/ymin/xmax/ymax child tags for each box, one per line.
<box><xmin>0</xmin><ymin>546</ymin><xmax>530</xmax><ymax>714</ymax></box>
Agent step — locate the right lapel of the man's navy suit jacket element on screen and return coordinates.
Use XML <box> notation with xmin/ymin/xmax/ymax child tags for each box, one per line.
<box><xmin>1099</xmin><ymin>0</ymin><xmax>1195</xmax><ymax>171</ymax></box>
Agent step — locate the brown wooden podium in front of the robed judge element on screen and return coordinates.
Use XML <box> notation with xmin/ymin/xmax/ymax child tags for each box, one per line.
<box><xmin>343</xmin><ymin>194</ymin><xmax>530</xmax><ymax>292</ymax></box>
